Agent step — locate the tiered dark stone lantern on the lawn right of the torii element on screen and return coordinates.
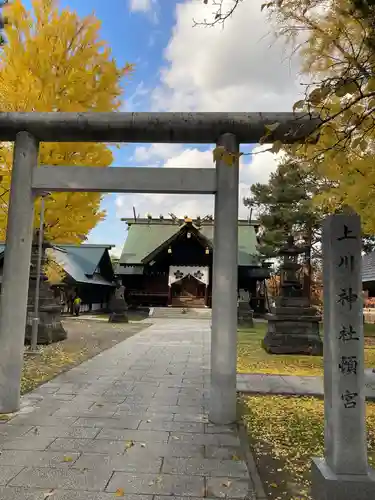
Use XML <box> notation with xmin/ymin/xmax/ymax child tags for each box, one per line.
<box><xmin>263</xmin><ymin>236</ymin><xmax>323</xmax><ymax>356</ymax></box>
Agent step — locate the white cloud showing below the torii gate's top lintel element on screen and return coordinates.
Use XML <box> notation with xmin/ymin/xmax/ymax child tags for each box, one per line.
<box><xmin>116</xmin><ymin>145</ymin><xmax>281</xmax><ymax>222</ymax></box>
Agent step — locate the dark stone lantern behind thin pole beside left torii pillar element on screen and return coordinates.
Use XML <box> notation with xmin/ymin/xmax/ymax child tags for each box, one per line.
<box><xmin>25</xmin><ymin>230</ymin><xmax>67</xmax><ymax>344</ymax></box>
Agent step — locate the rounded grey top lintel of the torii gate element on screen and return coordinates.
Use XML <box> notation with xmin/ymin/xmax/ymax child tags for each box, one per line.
<box><xmin>0</xmin><ymin>112</ymin><xmax>319</xmax><ymax>144</ymax></box>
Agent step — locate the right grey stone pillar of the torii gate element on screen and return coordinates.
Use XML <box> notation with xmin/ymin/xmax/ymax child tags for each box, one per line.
<box><xmin>209</xmin><ymin>134</ymin><xmax>239</xmax><ymax>425</ymax></box>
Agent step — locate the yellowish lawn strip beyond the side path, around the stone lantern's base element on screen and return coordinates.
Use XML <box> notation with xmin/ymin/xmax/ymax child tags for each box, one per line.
<box><xmin>237</xmin><ymin>323</ymin><xmax>375</xmax><ymax>375</ymax></box>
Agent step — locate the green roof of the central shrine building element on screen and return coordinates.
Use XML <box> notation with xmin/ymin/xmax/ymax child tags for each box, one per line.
<box><xmin>119</xmin><ymin>219</ymin><xmax>260</xmax><ymax>272</ymax></box>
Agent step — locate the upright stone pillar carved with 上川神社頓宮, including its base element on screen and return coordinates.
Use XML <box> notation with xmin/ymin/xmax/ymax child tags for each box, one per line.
<box><xmin>312</xmin><ymin>213</ymin><xmax>375</xmax><ymax>500</ymax></box>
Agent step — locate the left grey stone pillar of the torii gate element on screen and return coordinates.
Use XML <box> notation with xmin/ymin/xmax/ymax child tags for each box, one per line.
<box><xmin>0</xmin><ymin>132</ymin><xmax>38</xmax><ymax>413</ymax></box>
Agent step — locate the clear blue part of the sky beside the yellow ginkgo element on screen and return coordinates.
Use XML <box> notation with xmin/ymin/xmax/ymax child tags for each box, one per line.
<box><xmin>49</xmin><ymin>0</ymin><xmax>178</xmax><ymax>250</ymax></box>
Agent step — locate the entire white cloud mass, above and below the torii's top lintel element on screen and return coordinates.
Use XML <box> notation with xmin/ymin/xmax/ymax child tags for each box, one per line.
<box><xmin>116</xmin><ymin>0</ymin><xmax>296</xmax><ymax>226</ymax></box>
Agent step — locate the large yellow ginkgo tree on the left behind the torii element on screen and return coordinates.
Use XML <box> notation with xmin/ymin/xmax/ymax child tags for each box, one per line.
<box><xmin>0</xmin><ymin>0</ymin><xmax>132</xmax><ymax>243</ymax></box>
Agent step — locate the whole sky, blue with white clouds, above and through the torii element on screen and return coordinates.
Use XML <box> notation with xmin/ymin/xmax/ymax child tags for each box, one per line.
<box><xmin>17</xmin><ymin>0</ymin><xmax>300</xmax><ymax>251</ymax></box>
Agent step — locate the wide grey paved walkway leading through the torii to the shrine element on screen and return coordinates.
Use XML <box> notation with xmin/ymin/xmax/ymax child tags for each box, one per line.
<box><xmin>0</xmin><ymin>320</ymin><xmax>255</xmax><ymax>500</ymax></box>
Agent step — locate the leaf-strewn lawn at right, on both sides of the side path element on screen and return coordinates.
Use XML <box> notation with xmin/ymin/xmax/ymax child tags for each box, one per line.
<box><xmin>238</xmin><ymin>323</ymin><xmax>375</xmax><ymax>500</ymax></box>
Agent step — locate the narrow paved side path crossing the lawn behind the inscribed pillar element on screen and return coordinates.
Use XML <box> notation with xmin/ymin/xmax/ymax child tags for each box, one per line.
<box><xmin>237</xmin><ymin>368</ymin><xmax>375</xmax><ymax>401</ymax></box>
